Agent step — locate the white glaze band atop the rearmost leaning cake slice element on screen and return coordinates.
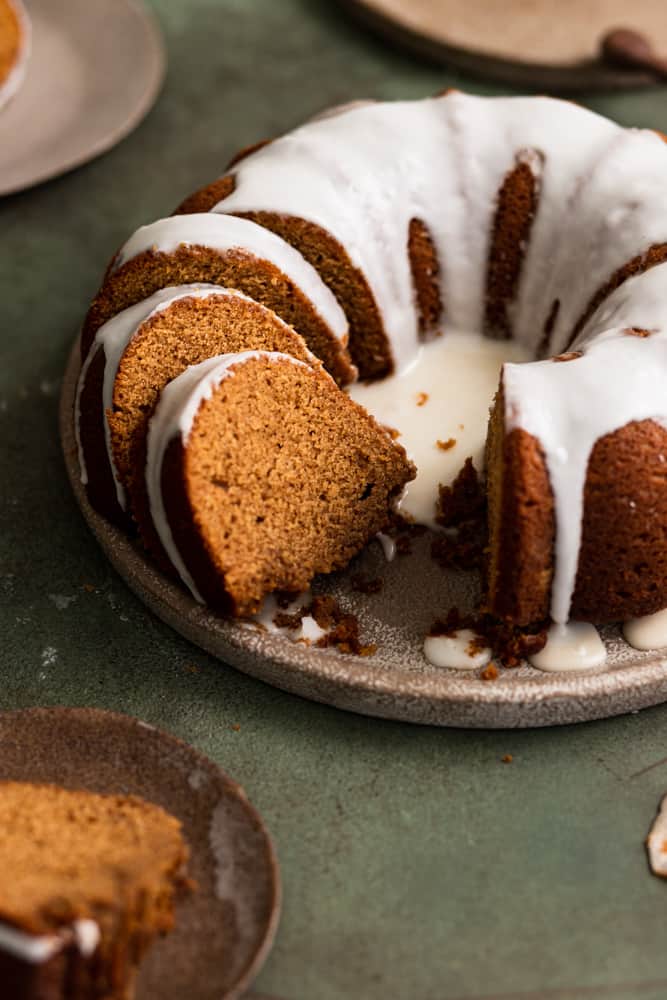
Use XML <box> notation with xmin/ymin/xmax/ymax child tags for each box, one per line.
<box><xmin>114</xmin><ymin>213</ymin><xmax>348</xmax><ymax>343</ymax></box>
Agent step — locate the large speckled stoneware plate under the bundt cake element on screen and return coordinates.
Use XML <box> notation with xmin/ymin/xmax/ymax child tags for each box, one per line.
<box><xmin>60</xmin><ymin>344</ymin><xmax>667</xmax><ymax>728</ymax></box>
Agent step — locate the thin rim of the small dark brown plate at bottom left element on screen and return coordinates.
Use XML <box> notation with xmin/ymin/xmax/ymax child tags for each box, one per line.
<box><xmin>0</xmin><ymin>705</ymin><xmax>283</xmax><ymax>1000</ymax></box>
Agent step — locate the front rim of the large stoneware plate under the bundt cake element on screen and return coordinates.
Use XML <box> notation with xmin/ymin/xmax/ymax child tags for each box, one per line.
<box><xmin>59</xmin><ymin>337</ymin><xmax>667</xmax><ymax>729</ymax></box>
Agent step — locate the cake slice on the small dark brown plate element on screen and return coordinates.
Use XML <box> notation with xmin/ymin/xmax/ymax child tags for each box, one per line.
<box><xmin>0</xmin><ymin>781</ymin><xmax>189</xmax><ymax>1000</ymax></box>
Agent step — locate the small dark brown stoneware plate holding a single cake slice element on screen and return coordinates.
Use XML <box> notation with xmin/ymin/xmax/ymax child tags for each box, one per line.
<box><xmin>0</xmin><ymin>708</ymin><xmax>280</xmax><ymax>1000</ymax></box>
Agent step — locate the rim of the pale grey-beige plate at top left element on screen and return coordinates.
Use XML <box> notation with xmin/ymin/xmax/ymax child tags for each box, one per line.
<box><xmin>0</xmin><ymin>0</ymin><xmax>167</xmax><ymax>198</ymax></box>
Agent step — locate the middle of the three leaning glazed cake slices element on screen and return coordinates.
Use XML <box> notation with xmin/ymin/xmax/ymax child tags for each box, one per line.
<box><xmin>76</xmin><ymin>285</ymin><xmax>320</xmax><ymax>544</ymax></box>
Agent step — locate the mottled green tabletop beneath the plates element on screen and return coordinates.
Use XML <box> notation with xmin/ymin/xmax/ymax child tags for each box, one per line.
<box><xmin>0</xmin><ymin>0</ymin><xmax>667</xmax><ymax>1000</ymax></box>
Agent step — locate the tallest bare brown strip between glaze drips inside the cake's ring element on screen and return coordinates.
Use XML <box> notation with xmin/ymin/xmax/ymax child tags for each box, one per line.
<box><xmin>484</xmin><ymin>150</ymin><xmax>540</xmax><ymax>340</ymax></box>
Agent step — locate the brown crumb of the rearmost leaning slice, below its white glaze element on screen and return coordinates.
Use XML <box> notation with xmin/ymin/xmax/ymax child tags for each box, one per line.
<box><xmin>81</xmin><ymin>245</ymin><xmax>355</xmax><ymax>385</ymax></box>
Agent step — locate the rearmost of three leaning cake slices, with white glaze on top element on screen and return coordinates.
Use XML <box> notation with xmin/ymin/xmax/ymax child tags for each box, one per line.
<box><xmin>81</xmin><ymin>214</ymin><xmax>356</xmax><ymax>385</ymax></box>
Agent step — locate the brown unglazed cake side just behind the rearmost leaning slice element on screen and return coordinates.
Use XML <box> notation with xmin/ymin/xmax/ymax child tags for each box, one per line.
<box><xmin>174</xmin><ymin>176</ymin><xmax>396</xmax><ymax>379</ymax></box>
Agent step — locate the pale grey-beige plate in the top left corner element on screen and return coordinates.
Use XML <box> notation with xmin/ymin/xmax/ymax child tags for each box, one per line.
<box><xmin>0</xmin><ymin>0</ymin><xmax>165</xmax><ymax>195</ymax></box>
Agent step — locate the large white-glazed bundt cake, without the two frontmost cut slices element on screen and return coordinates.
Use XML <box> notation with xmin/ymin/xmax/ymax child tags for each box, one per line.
<box><xmin>82</xmin><ymin>92</ymin><xmax>667</xmax><ymax>668</ymax></box>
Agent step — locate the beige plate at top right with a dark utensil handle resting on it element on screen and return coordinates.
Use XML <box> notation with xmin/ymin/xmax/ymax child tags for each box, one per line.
<box><xmin>338</xmin><ymin>0</ymin><xmax>667</xmax><ymax>92</ymax></box>
